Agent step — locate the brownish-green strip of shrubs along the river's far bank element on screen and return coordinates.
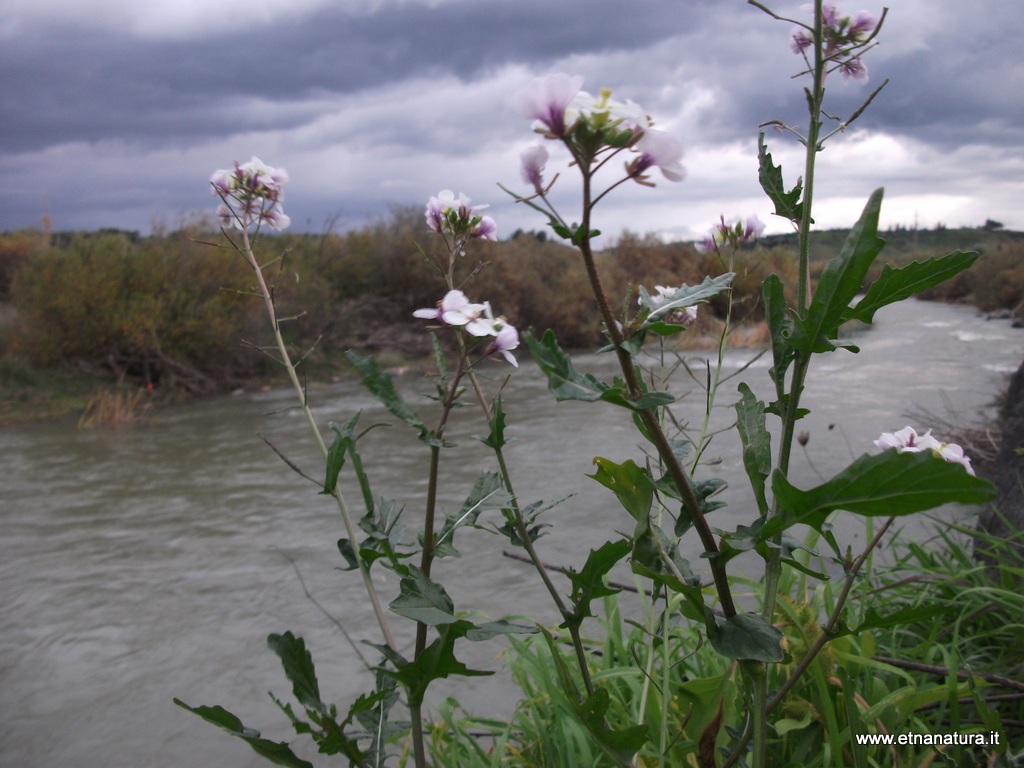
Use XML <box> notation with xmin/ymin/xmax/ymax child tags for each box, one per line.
<box><xmin>0</xmin><ymin>215</ymin><xmax>1024</xmax><ymax>423</ymax></box>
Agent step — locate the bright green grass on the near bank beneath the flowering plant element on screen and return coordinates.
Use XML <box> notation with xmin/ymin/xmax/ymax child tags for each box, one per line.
<box><xmin>411</xmin><ymin>522</ymin><xmax>1024</xmax><ymax>768</ymax></box>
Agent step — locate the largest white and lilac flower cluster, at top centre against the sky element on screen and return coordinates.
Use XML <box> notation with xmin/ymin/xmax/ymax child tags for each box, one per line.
<box><xmin>515</xmin><ymin>74</ymin><xmax>684</xmax><ymax>186</ymax></box>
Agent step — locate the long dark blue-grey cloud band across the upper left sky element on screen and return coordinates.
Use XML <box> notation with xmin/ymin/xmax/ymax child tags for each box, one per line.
<box><xmin>0</xmin><ymin>0</ymin><xmax>709</xmax><ymax>152</ymax></box>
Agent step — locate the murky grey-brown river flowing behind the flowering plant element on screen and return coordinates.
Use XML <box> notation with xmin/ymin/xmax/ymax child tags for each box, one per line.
<box><xmin>0</xmin><ymin>301</ymin><xmax>1024</xmax><ymax>768</ymax></box>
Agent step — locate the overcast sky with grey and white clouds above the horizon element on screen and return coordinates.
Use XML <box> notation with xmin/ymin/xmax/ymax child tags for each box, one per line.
<box><xmin>0</xmin><ymin>0</ymin><xmax>1024</xmax><ymax>240</ymax></box>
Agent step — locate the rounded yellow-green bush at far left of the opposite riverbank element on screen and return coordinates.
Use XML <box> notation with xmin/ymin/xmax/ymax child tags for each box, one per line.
<box><xmin>10</xmin><ymin>225</ymin><xmax>258</xmax><ymax>390</ymax></box>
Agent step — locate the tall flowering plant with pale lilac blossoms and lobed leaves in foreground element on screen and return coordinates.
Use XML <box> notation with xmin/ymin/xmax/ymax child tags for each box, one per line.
<box><xmin>172</xmin><ymin>0</ymin><xmax>992</xmax><ymax>768</ymax></box>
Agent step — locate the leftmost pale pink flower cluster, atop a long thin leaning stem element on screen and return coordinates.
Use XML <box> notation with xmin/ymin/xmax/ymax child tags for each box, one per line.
<box><xmin>210</xmin><ymin>157</ymin><xmax>292</xmax><ymax>230</ymax></box>
